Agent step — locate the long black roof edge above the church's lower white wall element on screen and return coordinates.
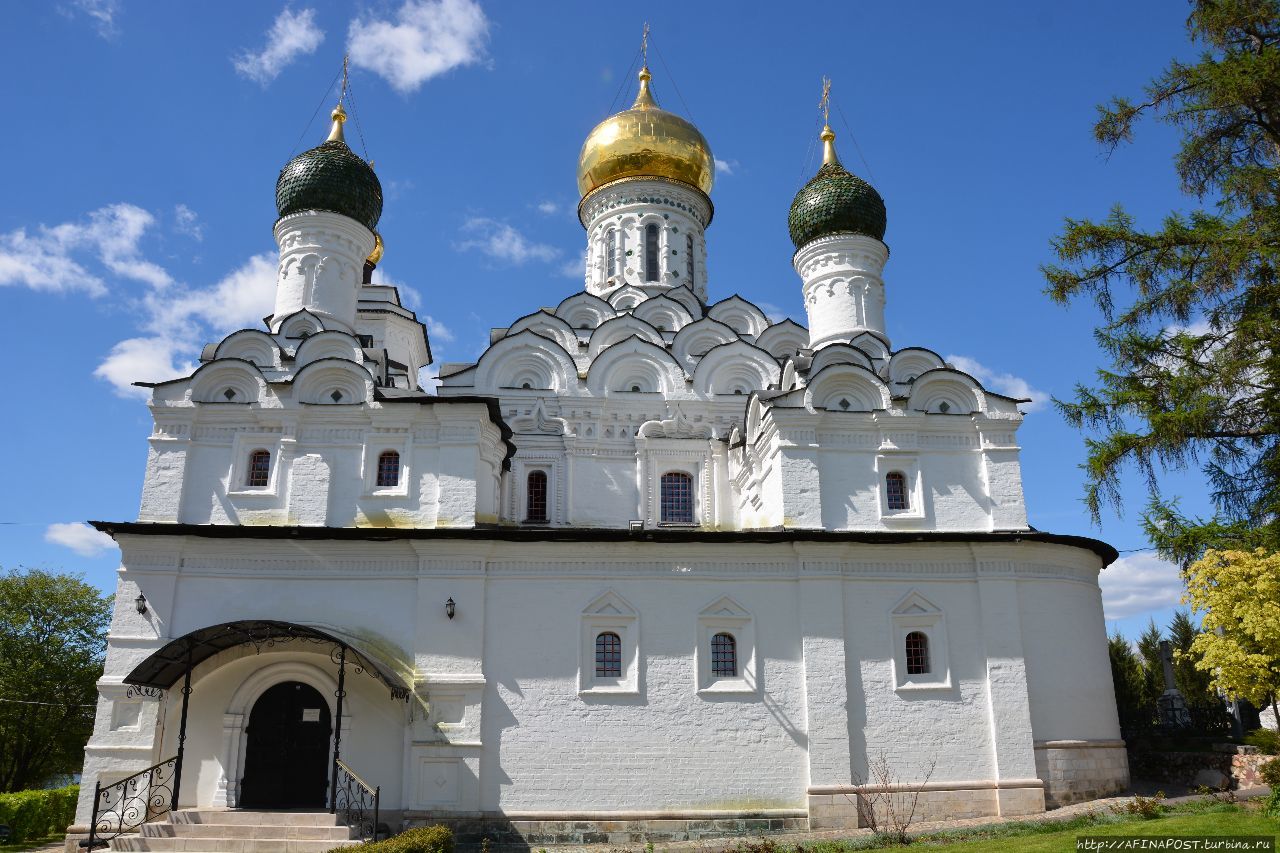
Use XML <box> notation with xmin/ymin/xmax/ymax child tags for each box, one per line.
<box><xmin>90</xmin><ymin>521</ymin><xmax>1120</xmax><ymax>566</ymax></box>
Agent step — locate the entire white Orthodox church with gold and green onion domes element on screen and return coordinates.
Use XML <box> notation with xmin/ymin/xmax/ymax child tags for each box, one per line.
<box><xmin>77</xmin><ymin>63</ymin><xmax>1128</xmax><ymax>853</ymax></box>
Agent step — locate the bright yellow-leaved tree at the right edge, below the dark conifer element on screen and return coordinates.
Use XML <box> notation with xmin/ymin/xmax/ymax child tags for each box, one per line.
<box><xmin>1184</xmin><ymin>548</ymin><xmax>1280</xmax><ymax>707</ymax></box>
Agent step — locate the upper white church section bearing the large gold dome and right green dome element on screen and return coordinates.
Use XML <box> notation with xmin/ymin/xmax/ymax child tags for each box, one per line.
<box><xmin>439</xmin><ymin>74</ymin><xmax>1027</xmax><ymax>529</ymax></box>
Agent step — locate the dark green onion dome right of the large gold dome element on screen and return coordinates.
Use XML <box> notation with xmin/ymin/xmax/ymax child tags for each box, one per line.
<box><xmin>787</xmin><ymin>127</ymin><xmax>886</xmax><ymax>248</ymax></box>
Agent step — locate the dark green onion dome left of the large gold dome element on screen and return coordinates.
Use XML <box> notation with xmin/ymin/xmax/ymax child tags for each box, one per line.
<box><xmin>275</xmin><ymin>104</ymin><xmax>383</xmax><ymax>231</ymax></box>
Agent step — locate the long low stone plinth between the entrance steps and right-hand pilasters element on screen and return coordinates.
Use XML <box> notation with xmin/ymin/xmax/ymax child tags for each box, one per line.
<box><xmin>404</xmin><ymin>808</ymin><xmax>809</xmax><ymax>849</ymax></box>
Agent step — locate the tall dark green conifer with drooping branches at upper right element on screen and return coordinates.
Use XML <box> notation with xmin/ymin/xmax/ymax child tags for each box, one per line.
<box><xmin>1043</xmin><ymin>0</ymin><xmax>1280</xmax><ymax>566</ymax></box>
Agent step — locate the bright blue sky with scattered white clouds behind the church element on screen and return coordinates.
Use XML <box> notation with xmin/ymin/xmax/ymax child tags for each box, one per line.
<box><xmin>0</xmin><ymin>0</ymin><xmax>1207</xmax><ymax>637</ymax></box>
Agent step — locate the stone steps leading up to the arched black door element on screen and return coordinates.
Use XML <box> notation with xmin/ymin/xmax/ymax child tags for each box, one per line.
<box><xmin>110</xmin><ymin>808</ymin><xmax>360</xmax><ymax>853</ymax></box>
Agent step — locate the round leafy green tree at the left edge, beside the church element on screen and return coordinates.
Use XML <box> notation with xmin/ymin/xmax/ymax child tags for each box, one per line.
<box><xmin>0</xmin><ymin>569</ymin><xmax>111</xmax><ymax>792</ymax></box>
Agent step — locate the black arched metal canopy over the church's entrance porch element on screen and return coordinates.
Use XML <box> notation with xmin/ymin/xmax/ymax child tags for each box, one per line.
<box><xmin>124</xmin><ymin>619</ymin><xmax>410</xmax><ymax>699</ymax></box>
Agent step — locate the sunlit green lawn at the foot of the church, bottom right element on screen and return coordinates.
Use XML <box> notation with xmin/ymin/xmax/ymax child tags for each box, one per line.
<box><xmin>780</xmin><ymin>799</ymin><xmax>1280</xmax><ymax>853</ymax></box>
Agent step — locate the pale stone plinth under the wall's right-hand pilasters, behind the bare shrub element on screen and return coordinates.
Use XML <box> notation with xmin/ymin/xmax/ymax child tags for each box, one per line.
<box><xmin>809</xmin><ymin>779</ymin><xmax>1044</xmax><ymax>830</ymax></box>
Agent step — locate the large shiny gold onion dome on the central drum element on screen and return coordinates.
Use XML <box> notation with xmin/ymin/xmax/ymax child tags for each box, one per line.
<box><xmin>577</xmin><ymin>67</ymin><xmax>716</xmax><ymax>196</ymax></box>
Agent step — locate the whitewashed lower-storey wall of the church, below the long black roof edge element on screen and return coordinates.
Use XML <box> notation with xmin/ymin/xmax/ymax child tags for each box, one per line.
<box><xmin>79</xmin><ymin>532</ymin><xmax>1125</xmax><ymax>825</ymax></box>
